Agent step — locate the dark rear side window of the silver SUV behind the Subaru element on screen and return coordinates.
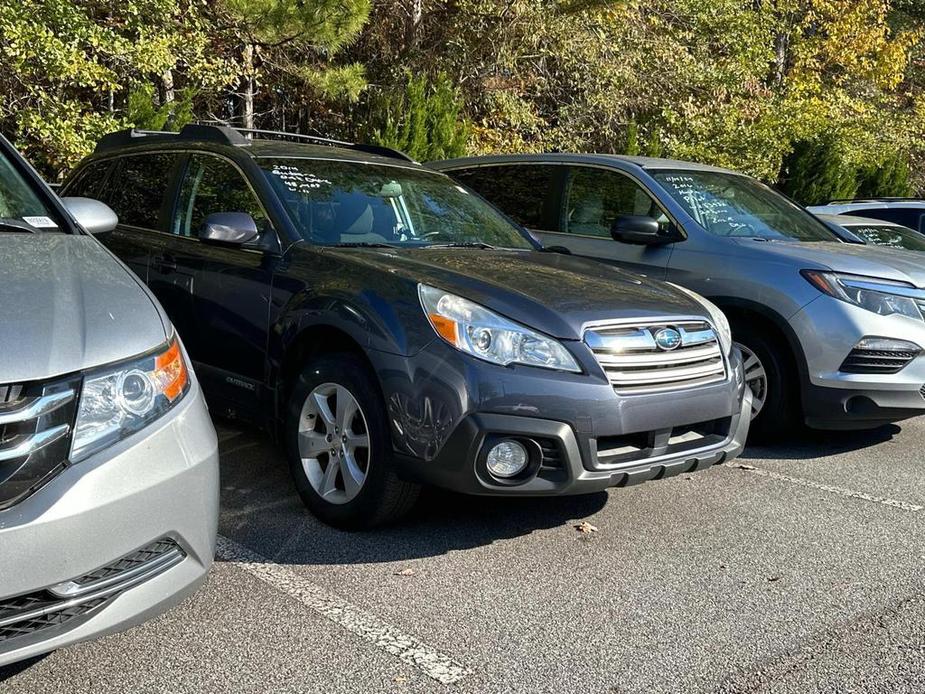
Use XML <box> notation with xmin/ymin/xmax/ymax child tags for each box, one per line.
<box><xmin>450</xmin><ymin>164</ymin><xmax>559</xmax><ymax>229</ymax></box>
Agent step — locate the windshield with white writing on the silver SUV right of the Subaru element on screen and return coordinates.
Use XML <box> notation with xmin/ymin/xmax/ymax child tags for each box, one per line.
<box><xmin>652</xmin><ymin>171</ymin><xmax>838</xmax><ymax>241</ymax></box>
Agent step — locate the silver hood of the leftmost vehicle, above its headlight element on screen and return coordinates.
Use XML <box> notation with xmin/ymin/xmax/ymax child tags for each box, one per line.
<box><xmin>0</xmin><ymin>233</ymin><xmax>167</xmax><ymax>383</ymax></box>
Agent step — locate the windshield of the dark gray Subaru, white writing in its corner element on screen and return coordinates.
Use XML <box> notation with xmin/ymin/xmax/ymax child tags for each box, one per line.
<box><xmin>258</xmin><ymin>158</ymin><xmax>535</xmax><ymax>249</ymax></box>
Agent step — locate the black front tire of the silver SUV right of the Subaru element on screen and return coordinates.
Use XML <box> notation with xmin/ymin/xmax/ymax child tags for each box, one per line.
<box><xmin>732</xmin><ymin>321</ymin><xmax>802</xmax><ymax>443</ymax></box>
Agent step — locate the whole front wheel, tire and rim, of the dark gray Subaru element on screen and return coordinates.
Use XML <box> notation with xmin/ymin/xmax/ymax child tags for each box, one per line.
<box><xmin>286</xmin><ymin>354</ymin><xmax>419</xmax><ymax>529</ymax></box>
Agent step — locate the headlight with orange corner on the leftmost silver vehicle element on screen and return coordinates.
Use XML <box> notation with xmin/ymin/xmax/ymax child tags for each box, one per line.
<box><xmin>71</xmin><ymin>337</ymin><xmax>190</xmax><ymax>462</ymax></box>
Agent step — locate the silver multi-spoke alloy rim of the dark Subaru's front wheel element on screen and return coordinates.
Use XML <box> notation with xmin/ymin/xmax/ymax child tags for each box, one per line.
<box><xmin>298</xmin><ymin>383</ymin><xmax>371</xmax><ymax>504</ymax></box>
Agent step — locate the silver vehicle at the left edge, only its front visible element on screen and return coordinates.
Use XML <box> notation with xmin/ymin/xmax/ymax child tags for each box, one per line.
<box><xmin>0</xmin><ymin>137</ymin><xmax>219</xmax><ymax>666</ymax></box>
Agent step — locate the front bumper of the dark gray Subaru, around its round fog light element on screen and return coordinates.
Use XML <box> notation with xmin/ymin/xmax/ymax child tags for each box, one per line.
<box><xmin>378</xmin><ymin>343</ymin><xmax>751</xmax><ymax>496</ymax></box>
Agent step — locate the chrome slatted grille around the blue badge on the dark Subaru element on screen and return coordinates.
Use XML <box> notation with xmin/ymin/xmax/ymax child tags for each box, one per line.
<box><xmin>585</xmin><ymin>320</ymin><xmax>726</xmax><ymax>394</ymax></box>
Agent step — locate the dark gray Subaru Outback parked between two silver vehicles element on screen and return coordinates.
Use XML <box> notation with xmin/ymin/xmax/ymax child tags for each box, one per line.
<box><xmin>64</xmin><ymin>126</ymin><xmax>751</xmax><ymax>527</ymax></box>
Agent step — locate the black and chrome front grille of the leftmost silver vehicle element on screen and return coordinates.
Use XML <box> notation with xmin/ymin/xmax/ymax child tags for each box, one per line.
<box><xmin>0</xmin><ymin>379</ymin><xmax>79</xmax><ymax>510</ymax></box>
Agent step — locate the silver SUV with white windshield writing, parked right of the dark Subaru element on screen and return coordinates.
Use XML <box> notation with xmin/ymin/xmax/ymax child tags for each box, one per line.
<box><xmin>431</xmin><ymin>154</ymin><xmax>925</xmax><ymax>436</ymax></box>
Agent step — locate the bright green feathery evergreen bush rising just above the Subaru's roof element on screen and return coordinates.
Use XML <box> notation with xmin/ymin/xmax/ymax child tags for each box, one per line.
<box><xmin>367</xmin><ymin>73</ymin><xmax>469</xmax><ymax>161</ymax></box>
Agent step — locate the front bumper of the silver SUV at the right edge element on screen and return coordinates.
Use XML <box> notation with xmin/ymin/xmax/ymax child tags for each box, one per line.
<box><xmin>790</xmin><ymin>296</ymin><xmax>925</xmax><ymax>429</ymax></box>
